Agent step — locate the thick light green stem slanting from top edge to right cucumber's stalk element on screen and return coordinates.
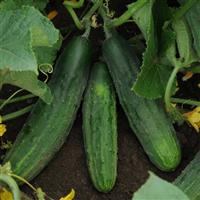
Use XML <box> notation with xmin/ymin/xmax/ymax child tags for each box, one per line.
<box><xmin>110</xmin><ymin>0</ymin><xmax>148</xmax><ymax>27</ymax></box>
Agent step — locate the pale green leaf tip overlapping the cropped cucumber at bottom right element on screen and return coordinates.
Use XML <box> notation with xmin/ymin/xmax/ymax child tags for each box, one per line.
<box><xmin>132</xmin><ymin>173</ymin><xmax>189</xmax><ymax>200</ymax></box>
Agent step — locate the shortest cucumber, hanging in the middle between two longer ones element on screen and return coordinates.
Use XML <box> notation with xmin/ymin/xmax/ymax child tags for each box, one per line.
<box><xmin>83</xmin><ymin>63</ymin><xmax>117</xmax><ymax>192</ymax></box>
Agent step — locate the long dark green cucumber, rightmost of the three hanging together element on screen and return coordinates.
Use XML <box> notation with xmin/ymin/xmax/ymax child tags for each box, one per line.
<box><xmin>103</xmin><ymin>33</ymin><xmax>181</xmax><ymax>171</ymax></box>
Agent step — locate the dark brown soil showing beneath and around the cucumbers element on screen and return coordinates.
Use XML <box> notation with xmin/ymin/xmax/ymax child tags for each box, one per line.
<box><xmin>0</xmin><ymin>1</ymin><xmax>200</xmax><ymax>200</ymax></box>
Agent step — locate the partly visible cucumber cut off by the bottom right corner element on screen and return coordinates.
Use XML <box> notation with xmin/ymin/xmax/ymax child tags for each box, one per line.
<box><xmin>174</xmin><ymin>151</ymin><xmax>200</xmax><ymax>200</ymax></box>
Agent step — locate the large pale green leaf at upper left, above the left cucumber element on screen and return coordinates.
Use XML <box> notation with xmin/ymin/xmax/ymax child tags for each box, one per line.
<box><xmin>0</xmin><ymin>7</ymin><xmax>60</xmax><ymax>103</ymax></box>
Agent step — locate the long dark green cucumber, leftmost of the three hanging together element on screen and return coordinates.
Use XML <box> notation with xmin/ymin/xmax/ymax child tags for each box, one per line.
<box><xmin>4</xmin><ymin>36</ymin><xmax>91</xmax><ymax>181</ymax></box>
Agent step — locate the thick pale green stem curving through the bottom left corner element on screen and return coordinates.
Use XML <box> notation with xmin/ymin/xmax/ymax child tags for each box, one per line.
<box><xmin>0</xmin><ymin>174</ymin><xmax>21</xmax><ymax>200</ymax></box>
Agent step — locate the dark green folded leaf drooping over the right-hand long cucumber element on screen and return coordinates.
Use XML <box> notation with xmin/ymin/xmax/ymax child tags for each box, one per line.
<box><xmin>133</xmin><ymin>0</ymin><xmax>171</xmax><ymax>99</ymax></box>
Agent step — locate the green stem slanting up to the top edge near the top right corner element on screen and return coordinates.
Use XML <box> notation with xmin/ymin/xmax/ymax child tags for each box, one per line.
<box><xmin>173</xmin><ymin>0</ymin><xmax>198</xmax><ymax>20</ymax></box>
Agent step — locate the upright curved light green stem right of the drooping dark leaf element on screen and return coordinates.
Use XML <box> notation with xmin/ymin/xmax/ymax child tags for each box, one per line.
<box><xmin>164</xmin><ymin>67</ymin><xmax>179</xmax><ymax>112</ymax></box>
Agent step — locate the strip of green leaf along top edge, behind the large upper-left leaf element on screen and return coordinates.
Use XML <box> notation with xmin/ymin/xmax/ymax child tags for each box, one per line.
<box><xmin>0</xmin><ymin>0</ymin><xmax>49</xmax><ymax>11</ymax></box>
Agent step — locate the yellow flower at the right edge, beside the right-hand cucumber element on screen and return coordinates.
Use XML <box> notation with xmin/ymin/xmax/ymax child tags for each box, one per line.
<box><xmin>183</xmin><ymin>106</ymin><xmax>200</xmax><ymax>133</ymax></box>
